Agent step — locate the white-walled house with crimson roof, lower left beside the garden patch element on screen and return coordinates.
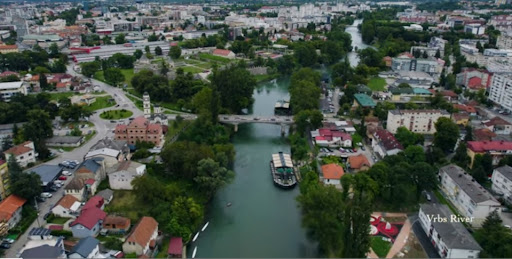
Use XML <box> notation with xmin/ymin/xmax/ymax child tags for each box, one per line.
<box><xmin>69</xmin><ymin>206</ymin><xmax>107</xmax><ymax>238</ymax></box>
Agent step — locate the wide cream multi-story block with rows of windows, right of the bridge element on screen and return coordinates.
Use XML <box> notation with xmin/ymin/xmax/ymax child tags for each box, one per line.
<box><xmin>386</xmin><ymin>110</ymin><xmax>450</xmax><ymax>134</ymax></box>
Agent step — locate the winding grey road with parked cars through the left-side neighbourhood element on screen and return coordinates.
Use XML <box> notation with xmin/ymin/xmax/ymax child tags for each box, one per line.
<box><xmin>5</xmin><ymin>65</ymin><xmax>143</xmax><ymax>258</ymax></box>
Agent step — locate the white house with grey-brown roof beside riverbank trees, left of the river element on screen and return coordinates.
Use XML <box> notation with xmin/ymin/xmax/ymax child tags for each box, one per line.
<box><xmin>108</xmin><ymin>161</ymin><xmax>146</xmax><ymax>190</ymax></box>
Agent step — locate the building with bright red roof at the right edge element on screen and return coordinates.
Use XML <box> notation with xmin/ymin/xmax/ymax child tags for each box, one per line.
<box><xmin>467</xmin><ymin>140</ymin><xmax>512</xmax><ymax>168</ymax></box>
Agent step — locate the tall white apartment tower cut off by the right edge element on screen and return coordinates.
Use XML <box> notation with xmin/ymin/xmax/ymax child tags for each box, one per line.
<box><xmin>489</xmin><ymin>73</ymin><xmax>512</xmax><ymax>111</ymax></box>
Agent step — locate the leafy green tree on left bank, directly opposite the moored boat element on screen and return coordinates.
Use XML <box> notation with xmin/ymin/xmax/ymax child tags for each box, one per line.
<box><xmin>194</xmin><ymin>158</ymin><xmax>235</xmax><ymax>197</ymax></box>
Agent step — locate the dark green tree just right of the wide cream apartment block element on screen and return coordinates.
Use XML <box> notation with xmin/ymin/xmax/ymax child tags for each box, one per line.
<box><xmin>434</xmin><ymin>117</ymin><xmax>459</xmax><ymax>152</ymax></box>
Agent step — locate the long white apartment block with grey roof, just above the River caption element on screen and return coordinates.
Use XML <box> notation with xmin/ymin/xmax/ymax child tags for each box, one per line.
<box><xmin>438</xmin><ymin>164</ymin><xmax>501</xmax><ymax>227</ymax></box>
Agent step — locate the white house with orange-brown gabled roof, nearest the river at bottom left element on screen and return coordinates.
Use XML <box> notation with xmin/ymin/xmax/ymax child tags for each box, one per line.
<box><xmin>123</xmin><ymin>217</ymin><xmax>158</xmax><ymax>256</ymax></box>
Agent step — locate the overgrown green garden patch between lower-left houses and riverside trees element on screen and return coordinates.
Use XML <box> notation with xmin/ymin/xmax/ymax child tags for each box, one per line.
<box><xmin>105</xmin><ymin>190</ymin><xmax>149</xmax><ymax>222</ymax></box>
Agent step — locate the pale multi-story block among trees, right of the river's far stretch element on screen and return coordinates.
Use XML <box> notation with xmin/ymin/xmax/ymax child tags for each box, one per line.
<box><xmin>391</xmin><ymin>54</ymin><xmax>444</xmax><ymax>75</ymax></box>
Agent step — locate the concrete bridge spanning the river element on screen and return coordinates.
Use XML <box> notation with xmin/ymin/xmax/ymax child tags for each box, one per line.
<box><xmin>219</xmin><ymin>114</ymin><xmax>294</xmax><ymax>135</ymax></box>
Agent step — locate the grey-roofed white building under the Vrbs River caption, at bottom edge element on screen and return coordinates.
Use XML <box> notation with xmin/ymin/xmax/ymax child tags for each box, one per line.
<box><xmin>418</xmin><ymin>203</ymin><xmax>482</xmax><ymax>258</ymax></box>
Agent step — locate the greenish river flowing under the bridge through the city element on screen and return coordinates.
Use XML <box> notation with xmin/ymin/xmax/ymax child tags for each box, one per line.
<box><xmin>187</xmin><ymin>17</ymin><xmax>368</xmax><ymax>258</ymax></box>
